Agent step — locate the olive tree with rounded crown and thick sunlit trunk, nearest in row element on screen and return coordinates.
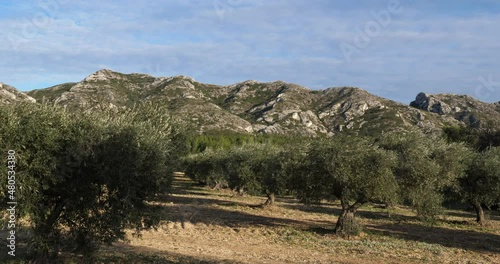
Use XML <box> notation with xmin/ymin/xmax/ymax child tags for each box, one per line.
<box><xmin>293</xmin><ymin>136</ymin><xmax>399</xmax><ymax>235</ymax></box>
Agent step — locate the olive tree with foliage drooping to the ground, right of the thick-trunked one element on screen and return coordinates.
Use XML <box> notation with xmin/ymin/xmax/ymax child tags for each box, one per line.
<box><xmin>379</xmin><ymin>131</ymin><xmax>472</xmax><ymax>220</ymax></box>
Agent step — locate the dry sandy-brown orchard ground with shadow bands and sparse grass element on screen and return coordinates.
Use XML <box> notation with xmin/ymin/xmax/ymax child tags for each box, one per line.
<box><xmin>0</xmin><ymin>175</ymin><xmax>500</xmax><ymax>264</ymax></box>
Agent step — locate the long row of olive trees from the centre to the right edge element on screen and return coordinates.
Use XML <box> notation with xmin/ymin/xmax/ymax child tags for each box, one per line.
<box><xmin>184</xmin><ymin>129</ymin><xmax>500</xmax><ymax>234</ymax></box>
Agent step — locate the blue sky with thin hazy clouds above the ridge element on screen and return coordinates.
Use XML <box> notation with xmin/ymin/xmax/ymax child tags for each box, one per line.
<box><xmin>0</xmin><ymin>0</ymin><xmax>500</xmax><ymax>103</ymax></box>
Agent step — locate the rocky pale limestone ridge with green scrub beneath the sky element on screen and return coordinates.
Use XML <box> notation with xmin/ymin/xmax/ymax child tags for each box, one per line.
<box><xmin>0</xmin><ymin>69</ymin><xmax>490</xmax><ymax>136</ymax></box>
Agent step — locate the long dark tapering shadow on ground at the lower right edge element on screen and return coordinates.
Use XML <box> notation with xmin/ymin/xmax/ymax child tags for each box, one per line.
<box><xmin>365</xmin><ymin>224</ymin><xmax>500</xmax><ymax>254</ymax></box>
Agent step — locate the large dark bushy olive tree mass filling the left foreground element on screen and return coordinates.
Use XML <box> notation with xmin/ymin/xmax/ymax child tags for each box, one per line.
<box><xmin>0</xmin><ymin>104</ymin><xmax>176</xmax><ymax>263</ymax></box>
